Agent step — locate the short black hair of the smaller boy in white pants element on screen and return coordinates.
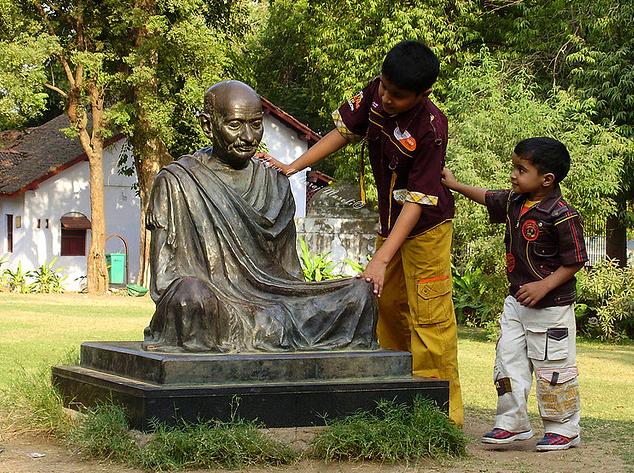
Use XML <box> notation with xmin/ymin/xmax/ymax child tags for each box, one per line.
<box><xmin>513</xmin><ymin>137</ymin><xmax>570</xmax><ymax>184</ymax></box>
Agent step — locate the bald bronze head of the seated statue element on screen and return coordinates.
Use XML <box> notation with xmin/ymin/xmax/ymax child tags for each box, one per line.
<box><xmin>199</xmin><ymin>80</ymin><xmax>264</xmax><ymax>169</ymax></box>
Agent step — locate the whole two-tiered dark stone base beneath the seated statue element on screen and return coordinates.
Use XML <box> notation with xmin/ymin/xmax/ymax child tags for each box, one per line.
<box><xmin>53</xmin><ymin>342</ymin><xmax>449</xmax><ymax>430</ymax></box>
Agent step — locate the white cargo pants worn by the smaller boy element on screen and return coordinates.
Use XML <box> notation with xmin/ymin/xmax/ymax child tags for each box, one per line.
<box><xmin>493</xmin><ymin>296</ymin><xmax>581</xmax><ymax>437</ymax></box>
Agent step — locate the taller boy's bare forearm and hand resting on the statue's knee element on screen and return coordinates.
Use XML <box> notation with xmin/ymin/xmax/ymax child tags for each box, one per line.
<box><xmin>357</xmin><ymin>202</ymin><xmax>423</xmax><ymax>297</ymax></box>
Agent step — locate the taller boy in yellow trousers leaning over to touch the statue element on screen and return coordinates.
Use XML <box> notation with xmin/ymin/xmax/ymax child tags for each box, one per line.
<box><xmin>264</xmin><ymin>41</ymin><xmax>464</xmax><ymax>426</ymax></box>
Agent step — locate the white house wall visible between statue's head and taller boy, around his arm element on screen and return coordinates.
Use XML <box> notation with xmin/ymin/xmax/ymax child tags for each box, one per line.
<box><xmin>262</xmin><ymin>115</ymin><xmax>308</xmax><ymax>217</ymax></box>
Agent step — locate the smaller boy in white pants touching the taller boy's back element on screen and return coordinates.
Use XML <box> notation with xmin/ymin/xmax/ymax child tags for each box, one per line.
<box><xmin>443</xmin><ymin>138</ymin><xmax>588</xmax><ymax>451</ymax></box>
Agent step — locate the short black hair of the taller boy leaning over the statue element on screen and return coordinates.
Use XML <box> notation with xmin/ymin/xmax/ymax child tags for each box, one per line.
<box><xmin>381</xmin><ymin>41</ymin><xmax>440</xmax><ymax>94</ymax></box>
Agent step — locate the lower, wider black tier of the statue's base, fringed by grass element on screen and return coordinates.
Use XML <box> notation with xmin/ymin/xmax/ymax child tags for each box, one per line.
<box><xmin>53</xmin><ymin>366</ymin><xmax>449</xmax><ymax>430</ymax></box>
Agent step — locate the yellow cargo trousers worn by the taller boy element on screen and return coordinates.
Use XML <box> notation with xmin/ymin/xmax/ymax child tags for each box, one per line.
<box><xmin>376</xmin><ymin>221</ymin><xmax>464</xmax><ymax>427</ymax></box>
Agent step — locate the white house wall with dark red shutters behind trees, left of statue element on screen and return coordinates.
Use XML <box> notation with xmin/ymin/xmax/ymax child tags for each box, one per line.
<box><xmin>0</xmin><ymin>140</ymin><xmax>139</xmax><ymax>290</ymax></box>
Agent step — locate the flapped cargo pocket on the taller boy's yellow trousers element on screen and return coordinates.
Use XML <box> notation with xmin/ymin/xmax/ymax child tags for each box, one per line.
<box><xmin>414</xmin><ymin>276</ymin><xmax>453</xmax><ymax>325</ymax></box>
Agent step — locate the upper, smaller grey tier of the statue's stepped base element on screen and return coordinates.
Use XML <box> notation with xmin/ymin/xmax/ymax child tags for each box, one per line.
<box><xmin>80</xmin><ymin>342</ymin><xmax>412</xmax><ymax>385</ymax></box>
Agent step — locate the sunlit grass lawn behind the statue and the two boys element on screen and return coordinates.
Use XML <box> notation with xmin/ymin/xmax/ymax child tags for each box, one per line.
<box><xmin>0</xmin><ymin>293</ymin><xmax>634</xmax><ymax>466</ymax></box>
